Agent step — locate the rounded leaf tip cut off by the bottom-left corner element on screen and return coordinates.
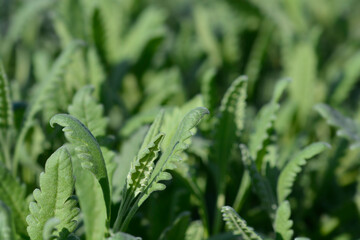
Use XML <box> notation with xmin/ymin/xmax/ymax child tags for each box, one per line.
<box><xmin>0</xmin><ymin>201</ymin><xmax>16</xmax><ymax>240</ymax></box>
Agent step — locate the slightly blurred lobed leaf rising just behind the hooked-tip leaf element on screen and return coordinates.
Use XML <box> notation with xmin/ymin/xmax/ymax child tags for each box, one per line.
<box><xmin>68</xmin><ymin>86</ymin><xmax>107</xmax><ymax>137</ymax></box>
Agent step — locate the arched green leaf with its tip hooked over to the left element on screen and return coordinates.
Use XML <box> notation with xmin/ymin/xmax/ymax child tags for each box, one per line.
<box><xmin>50</xmin><ymin>114</ymin><xmax>111</xmax><ymax>219</ymax></box>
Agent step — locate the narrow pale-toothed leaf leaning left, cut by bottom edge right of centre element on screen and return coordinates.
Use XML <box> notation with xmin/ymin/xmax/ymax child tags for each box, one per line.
<box><xmin>221</xmin><ymin>206</ymin><xmax>262</xmax><ymax>240</ymax></box>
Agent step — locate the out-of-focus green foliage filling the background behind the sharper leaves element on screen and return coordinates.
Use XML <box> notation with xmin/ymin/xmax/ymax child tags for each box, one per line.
<box><xmin>0</xmin><ymin>0</ymin><xmax>360</xmax><ymax>240</ymax></box>
